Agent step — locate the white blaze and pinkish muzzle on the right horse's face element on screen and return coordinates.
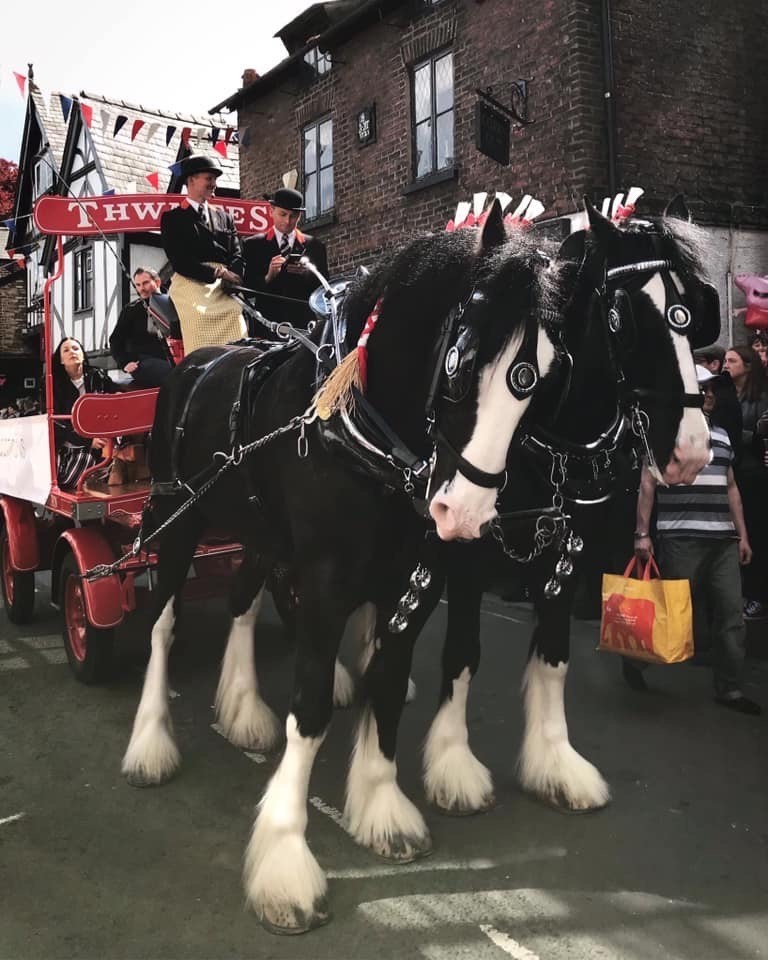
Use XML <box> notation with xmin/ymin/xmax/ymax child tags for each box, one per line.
<box><xmin>643</xmin><ymin>273</ymin><xmax>709</xmax><ymax>483</ymax></box>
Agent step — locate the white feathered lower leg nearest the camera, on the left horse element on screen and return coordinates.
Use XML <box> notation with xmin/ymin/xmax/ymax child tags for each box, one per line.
<box><xmin>243</xmin><ymin>714</ymin><xmax>327</xmax><ymax>926</ymax></box>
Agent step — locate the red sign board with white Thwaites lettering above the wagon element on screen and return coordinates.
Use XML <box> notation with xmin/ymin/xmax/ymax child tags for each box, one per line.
<box><xmin>34</xmin><ymin>193</ymin><xmax>272</xmax><ymax>237</ymax></box>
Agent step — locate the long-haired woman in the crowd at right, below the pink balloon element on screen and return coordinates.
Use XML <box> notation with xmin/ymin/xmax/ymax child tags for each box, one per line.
<box><xmin>723</xmin><ymin>346</ymin><xmax>768</xmax><ymax>620</ymax></box>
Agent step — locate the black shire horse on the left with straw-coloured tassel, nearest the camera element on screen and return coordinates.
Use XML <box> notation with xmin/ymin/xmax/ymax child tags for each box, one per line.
<box><xmin>122</xmin><ymin>203</ymin><xmax>555</xmax><ymax>933</ymax></box>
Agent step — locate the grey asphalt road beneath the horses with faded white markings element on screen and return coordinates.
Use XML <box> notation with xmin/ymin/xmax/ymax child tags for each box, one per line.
<box><xmin>0</xmin><ymin>578</ymin><xmax>768</xmax><ymax>960</ymax></box>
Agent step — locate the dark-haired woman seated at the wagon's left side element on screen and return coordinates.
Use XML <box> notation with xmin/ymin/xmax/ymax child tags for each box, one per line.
<box><xmin>52</xmin><ymin>337</ymin><xmax>120</xmax><ymax>487</ymax></box>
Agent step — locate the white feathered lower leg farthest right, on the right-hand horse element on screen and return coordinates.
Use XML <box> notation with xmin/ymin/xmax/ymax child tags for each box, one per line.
<box><xmin>518</xmin><ymin>654</ymin><xmax>610</xmax><ymax>810</ymax></box>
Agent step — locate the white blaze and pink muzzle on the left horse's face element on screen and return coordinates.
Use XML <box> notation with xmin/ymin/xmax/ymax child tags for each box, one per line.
<box><xmin>429</xmin><ymin>330</ymin><xmax>555</xmax><ymax>540</ymax></box>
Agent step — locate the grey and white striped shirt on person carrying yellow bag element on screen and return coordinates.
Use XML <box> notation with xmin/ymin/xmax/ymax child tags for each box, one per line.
<box><xmin>656</xmin><ymin>426</ymin><xmax>738</xmax><ymax>539</ymax></box>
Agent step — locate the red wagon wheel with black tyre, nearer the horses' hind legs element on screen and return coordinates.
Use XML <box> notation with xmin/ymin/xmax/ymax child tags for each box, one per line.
<box><xmin>59</xmin><ymin>553</ymin><xmax>115</xmax><ymax>684</ymax></box>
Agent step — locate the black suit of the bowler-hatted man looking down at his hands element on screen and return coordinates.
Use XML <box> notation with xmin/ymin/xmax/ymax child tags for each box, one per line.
<box><xmin>243</xmin><ymin>229</ymin><xmax>328</xmax><ymax>327</ymax></box>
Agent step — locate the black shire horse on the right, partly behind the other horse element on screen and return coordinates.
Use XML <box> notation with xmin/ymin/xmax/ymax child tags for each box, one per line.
<box><xmin>378</xmin><ymin>201</ymin><xmax>720</xmax><ymax>813</ymax></box>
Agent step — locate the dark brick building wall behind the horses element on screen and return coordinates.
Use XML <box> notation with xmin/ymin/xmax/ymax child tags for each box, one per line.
<box><xmin>219</xmin><ymin>0</ymin><xmax>768</xmax><ymax>314</ymax></box>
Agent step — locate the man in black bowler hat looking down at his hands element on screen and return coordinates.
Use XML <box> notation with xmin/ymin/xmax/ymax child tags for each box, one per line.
<box><xmin>243</xmin><ymin>187</ymin><xmax>328</xmax><ymax>335</ymax></box>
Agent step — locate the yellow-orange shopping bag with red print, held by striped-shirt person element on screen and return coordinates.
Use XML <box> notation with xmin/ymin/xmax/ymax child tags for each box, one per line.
<box><xmin>598</xmin><ymin>557</ymin><xmax>693</xmax><ymax>663</ymax></box>
